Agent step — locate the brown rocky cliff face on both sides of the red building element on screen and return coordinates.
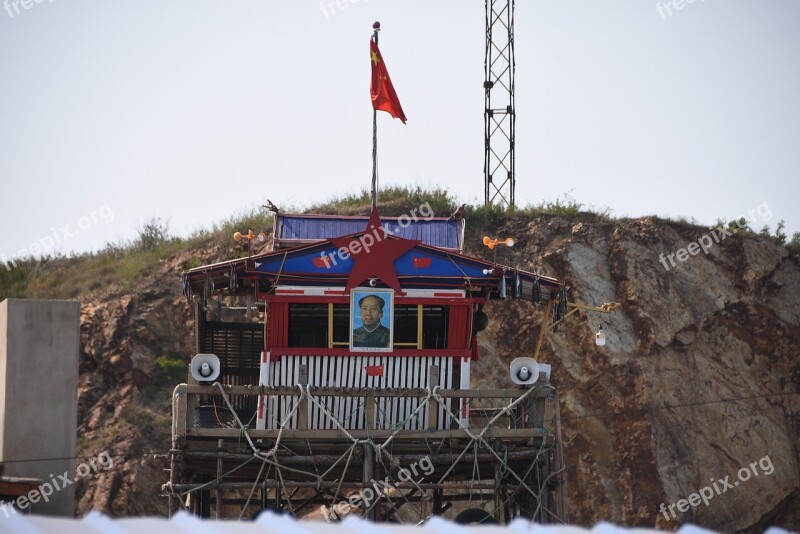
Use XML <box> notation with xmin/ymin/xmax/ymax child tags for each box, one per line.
<box><xmin>72</xmin><ymin>215</ymin><xmax>800</xmax><ymax>531</ymax></box>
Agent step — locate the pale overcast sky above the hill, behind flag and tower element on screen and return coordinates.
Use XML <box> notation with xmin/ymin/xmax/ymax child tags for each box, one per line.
<box><xmin>0</xmin><ymin>0</ymin><xmax>800</xmax><ymax>259</ymax></box>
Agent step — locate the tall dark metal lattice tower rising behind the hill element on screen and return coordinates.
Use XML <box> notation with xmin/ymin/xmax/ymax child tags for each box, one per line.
<box><xmin>483</xmin><ymin>0</ymin><xmax>516</xmax><ymax>206</ymax></box>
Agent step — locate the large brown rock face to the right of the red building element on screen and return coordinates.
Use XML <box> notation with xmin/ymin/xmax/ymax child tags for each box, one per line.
<box><xmin>476</xmin><ymin>217</ymin><xmax>800</xmax><ymax>532</ymax></box>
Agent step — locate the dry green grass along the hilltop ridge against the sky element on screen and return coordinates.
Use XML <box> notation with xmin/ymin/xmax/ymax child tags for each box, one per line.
<box><xmin>0</xmin><ymin>185</ymin><xmax>800</xmax><ymax>301</ymax></box>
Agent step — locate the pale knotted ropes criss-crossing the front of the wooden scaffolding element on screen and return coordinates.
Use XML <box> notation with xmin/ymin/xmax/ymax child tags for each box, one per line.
<box><xmin>172</xmin><ymin>382</ymin><xmax>564</xmax><ymax>522</ymax></box>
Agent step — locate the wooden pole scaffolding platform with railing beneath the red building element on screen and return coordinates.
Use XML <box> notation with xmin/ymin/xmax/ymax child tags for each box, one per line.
<box><xmin>163</xmin><ymin>383</ymin><xmax>566</xmax><ymax>524</ymax></box>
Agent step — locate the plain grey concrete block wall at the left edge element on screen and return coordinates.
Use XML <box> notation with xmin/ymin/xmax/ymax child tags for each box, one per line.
<box><xmin>0</xmin><ymin>299</ymin><xmax>80</xmax><ymax>519</ymax></box>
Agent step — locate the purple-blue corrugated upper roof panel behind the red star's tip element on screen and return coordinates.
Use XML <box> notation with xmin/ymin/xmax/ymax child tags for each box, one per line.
<box><xmin>273</xmin><ymin>213</ymin><xmax>464</xmax><ymax>252</ymax></box>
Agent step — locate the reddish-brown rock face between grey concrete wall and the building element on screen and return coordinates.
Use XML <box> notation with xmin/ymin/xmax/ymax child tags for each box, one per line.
<box><xmin>76</xmin><ymin>253</ymin><xmax>202</xmax><ymax>516</ymax></box>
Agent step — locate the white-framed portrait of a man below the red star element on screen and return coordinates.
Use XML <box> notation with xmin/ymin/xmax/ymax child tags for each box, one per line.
<box><xmin>350</xmin><ymin>288</ymin><xmax>394</xmax><ymax>352</ymax></box>
